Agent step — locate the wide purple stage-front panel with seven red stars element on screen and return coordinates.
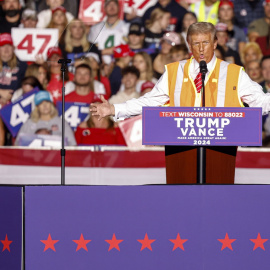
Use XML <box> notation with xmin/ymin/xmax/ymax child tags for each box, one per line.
<box><xmin>25</xmin><ymin>185</ymin><xmax>270</xmax><ymax>270</ymax></box>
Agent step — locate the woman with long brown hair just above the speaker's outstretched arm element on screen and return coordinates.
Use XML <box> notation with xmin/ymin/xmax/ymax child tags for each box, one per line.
<box><xmin>133</xmin><ymin>52</ymin><xmax>157</xmax><ymax>93</ymax></box>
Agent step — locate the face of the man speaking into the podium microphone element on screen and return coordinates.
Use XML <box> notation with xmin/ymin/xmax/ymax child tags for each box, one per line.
<box><xmin>189</xmin><ymin>33</ymin><xmax>217</xmax><ymax>63</ymax></box>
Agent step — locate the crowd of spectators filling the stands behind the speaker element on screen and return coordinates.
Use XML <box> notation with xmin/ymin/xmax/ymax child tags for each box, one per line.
<box><xmin>0</xmin><ymin>0</ymin><xmax>270</xmax><ymax>145</ymax></box>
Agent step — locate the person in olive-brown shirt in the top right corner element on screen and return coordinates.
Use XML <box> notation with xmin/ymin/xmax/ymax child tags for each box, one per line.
<box><xmin>248</xmin><ymin>0</ymin><xmax>270</xmax><ymax>41</ymax></box>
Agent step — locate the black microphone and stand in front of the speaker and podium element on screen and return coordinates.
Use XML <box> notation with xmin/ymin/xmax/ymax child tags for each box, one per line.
<box><xmin>197</xmin><ymin>63</ymin><xmax>207</xmax><ymax>185</ymax></box>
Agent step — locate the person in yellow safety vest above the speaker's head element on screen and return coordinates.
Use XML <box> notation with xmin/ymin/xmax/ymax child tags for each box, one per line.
<box><xmin>190</xmin><ymin>0</ymin><xmax>219</xmax><ymax>25</ymax></box>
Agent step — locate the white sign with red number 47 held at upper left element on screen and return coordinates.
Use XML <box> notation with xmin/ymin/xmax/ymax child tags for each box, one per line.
<box><xmin>11</xmin><ymin>28</ymin><xmax>58</xmax><ymax>61</ymax></box>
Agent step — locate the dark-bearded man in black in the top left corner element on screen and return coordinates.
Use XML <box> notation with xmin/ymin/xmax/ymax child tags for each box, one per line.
<box><xmin>0</xmin><ymin>0</ymin><xmax>22</xmax><ymax>34</ymax></box>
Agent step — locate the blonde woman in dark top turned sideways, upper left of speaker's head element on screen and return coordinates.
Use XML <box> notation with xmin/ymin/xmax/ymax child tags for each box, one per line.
<box><xmin>144</xmin><ymin>8</ymin><xmax>171</xmax><ymax>52</ymax></box>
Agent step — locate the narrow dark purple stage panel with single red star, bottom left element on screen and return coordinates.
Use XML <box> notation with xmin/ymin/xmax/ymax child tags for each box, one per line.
<box><xmin>0</xmin><ymin>186</ymin><xmax>23</xmax><ymax>270</ymax></box>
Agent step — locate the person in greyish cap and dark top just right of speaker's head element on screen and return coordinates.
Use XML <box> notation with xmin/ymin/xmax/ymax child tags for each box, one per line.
<box><xmin>216</xmin><ymin>23</ymin><xmax>242</xmax><ymax>66</ymax></box>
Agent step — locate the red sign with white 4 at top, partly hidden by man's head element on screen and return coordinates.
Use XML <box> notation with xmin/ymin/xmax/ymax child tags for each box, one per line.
<box><xmin>79</xmin><ymin>0</ymin><xmax>124</xmax><ymax>25</ymax></box>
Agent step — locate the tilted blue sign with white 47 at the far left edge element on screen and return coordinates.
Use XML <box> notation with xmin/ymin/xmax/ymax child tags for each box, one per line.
<box><xmin>0</xmin><ymin>88</ymin><xmax>39</xmax><ymax>137</ymax></box>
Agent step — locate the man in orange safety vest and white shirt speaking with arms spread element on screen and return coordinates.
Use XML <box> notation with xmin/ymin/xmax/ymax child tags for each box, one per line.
<box><xmin>90</xmin><ymin>22</ymin><xmax>270</xmax><ymax>120</ymax></box>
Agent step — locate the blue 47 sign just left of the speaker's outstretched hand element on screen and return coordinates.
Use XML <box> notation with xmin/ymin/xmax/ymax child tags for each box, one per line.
<box><xmin>56</xmin><ymin>101</ymin><xmax>90</xmax><ymax>130</ymax></box>
